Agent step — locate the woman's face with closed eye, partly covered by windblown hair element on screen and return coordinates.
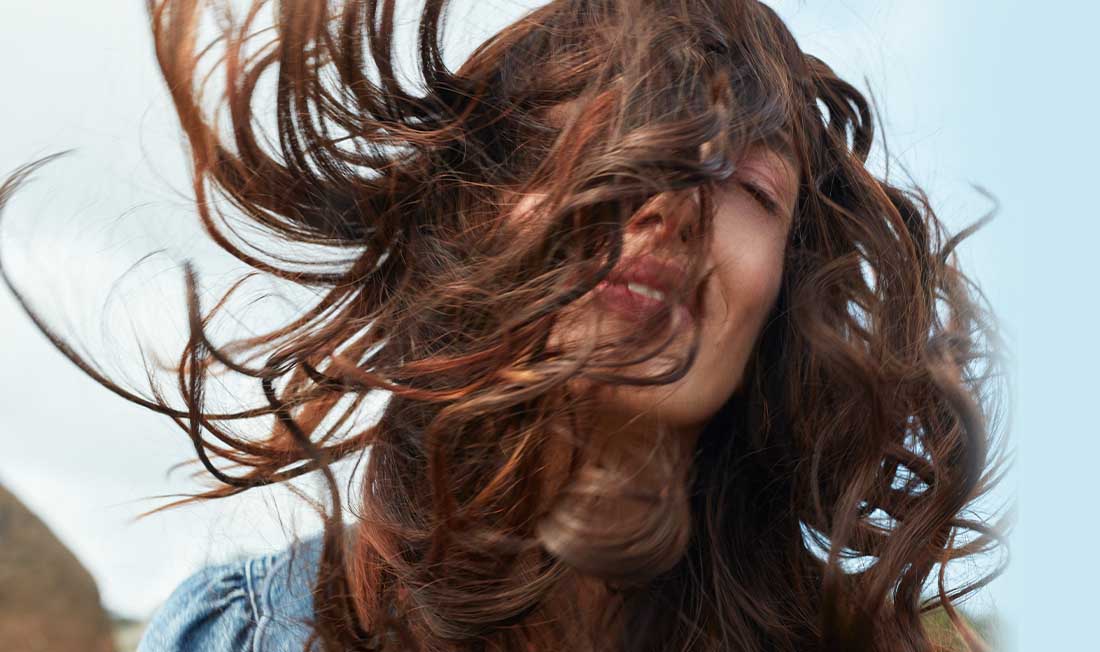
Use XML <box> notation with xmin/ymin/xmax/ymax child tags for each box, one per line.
<box><xmin>518</xmin><ymin>137</ymin><xmax>799</xmax><ymax>441</ymax></box>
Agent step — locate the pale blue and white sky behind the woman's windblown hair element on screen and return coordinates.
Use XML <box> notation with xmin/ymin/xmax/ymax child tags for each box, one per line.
<box><xmin>0</xmin><ymin>0</ymin><xmax>1082</xmax><ymax>650</ymax></box>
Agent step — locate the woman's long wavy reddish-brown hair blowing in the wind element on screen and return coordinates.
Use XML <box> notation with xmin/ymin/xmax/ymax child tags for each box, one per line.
<box><xmin>0</xmin><ymin>0</ymin><xmax>1004</xmax><ymax>652</ymax></box>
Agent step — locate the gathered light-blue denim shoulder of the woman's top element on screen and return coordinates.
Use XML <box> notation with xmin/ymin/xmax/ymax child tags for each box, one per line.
<box><xmin>138</xmin><ymin>538</ymin><xmax>321</xmax><ymax>652</ymax></box>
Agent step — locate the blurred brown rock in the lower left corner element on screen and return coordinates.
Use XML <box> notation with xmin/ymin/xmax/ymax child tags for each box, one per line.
<box><xmin>0</xmin><ymin>486</ymin><xmax>114</xmax><ymax>652</ymax></box>
